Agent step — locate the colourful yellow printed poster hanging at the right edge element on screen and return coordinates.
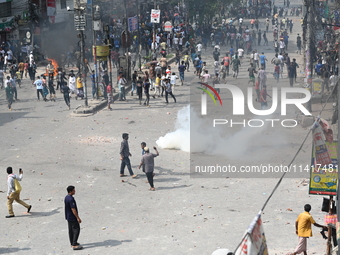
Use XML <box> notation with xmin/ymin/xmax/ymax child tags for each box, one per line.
<box><xmin>309</xmin><ymin>141</ymin><xmax>338</xmax><ymax>196</ymax></box>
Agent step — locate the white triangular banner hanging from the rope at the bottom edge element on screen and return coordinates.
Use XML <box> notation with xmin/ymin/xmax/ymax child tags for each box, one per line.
<box><xmin>235</xmin><ymin>211</ymin><xmax>268</xmax><ymax>255</ymax></box>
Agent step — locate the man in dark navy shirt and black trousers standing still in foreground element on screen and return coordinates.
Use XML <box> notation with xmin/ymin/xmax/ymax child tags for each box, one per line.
<box><xmin>64</xmin><ymin>186</ymin><xmax>83</xmax><ymax>250</ymax></box>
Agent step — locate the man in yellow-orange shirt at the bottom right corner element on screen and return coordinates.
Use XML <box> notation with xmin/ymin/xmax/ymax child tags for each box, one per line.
<box><xmin>289</xmin><ymin>204</ymin><xmax>328</xmax><ymax>255</ymax></box>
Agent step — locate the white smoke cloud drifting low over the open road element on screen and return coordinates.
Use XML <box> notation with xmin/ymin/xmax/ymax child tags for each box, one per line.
<box><xmin>156</xmin><ymin>105</ymin><xmax>286</xmax><ymax>160</ymax></box>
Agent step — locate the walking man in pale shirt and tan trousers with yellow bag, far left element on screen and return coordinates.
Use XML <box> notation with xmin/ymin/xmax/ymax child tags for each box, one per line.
<box><xmin>6</xmin><ymin>166</ymin><xmax>32</xmax><ymax>218</ymax></box>
